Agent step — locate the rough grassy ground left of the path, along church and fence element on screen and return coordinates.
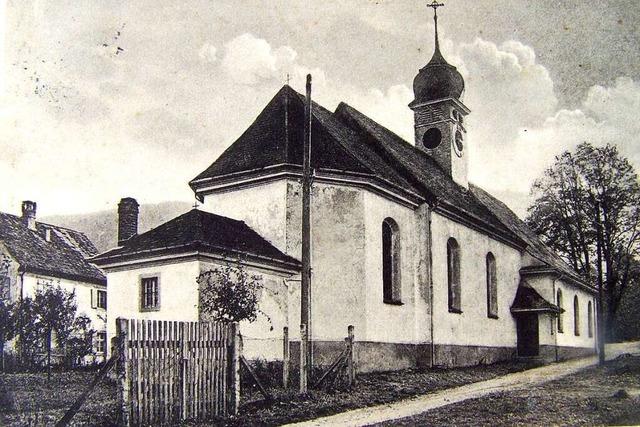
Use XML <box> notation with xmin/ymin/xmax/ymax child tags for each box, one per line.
<box><xmin>0</xmin><ymin>363</ymin><xmax>530</xmax><ymax>426</ymax></box>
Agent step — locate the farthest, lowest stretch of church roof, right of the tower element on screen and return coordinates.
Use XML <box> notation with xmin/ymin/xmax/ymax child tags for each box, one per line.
<box><xmin>469</xmin><ymin>185</ymin><xmax>591</xmax><ymax>288</ymax></box>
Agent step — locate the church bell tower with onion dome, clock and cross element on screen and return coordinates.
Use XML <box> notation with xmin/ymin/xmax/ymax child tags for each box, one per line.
<box><xmin>409</xmin><ymin>0</ymin><xmax>470</xmax><ymax>188</ymax></box>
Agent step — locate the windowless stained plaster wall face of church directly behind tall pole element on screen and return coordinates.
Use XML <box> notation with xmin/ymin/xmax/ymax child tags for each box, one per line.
<box><xmin>286</xmin><ymin>181</ymin><xmax>367</xmax><ymax>341</ymax></box>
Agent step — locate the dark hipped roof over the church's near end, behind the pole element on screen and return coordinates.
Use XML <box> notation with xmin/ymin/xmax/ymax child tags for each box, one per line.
<box><xmin>190</xmin><ymin>86</ymin><xmax>417</xmax><ymax>201</ymax></box>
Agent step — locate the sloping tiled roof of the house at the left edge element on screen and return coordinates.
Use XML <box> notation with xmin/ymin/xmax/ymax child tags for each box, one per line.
<box><xmin>0</xmin><ymin>212</ymin><xmax>106</xmax><ymax>284</ymax></box>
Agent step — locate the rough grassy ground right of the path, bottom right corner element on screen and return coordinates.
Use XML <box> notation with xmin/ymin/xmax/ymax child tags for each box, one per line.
<box><xmin>382</xmin><ymin>357</ymin><xmax>640</xmax><ymax>426</ymax></box>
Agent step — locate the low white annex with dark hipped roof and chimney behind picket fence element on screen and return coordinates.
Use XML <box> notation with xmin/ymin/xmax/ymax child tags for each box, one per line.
<box><xmin>92</xmin><ymin>198</ymin><xmax>300</xmax><ymax>359</ymax></box>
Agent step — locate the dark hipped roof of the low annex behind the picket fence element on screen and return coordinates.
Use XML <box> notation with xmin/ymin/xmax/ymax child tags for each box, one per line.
<box><xmin>92</xmin><ymin>209</ymin><xmax>300</xmax><ymax>269</ymax></box>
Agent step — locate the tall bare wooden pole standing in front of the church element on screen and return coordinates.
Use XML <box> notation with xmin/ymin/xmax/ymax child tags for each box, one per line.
<box><xmin>300</xmin><ymin>74</ymin><xmax>311</xmax><ymax>393</ymax></box>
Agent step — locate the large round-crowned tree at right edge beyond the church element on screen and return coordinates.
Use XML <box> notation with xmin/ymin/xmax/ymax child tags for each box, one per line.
<box><xmin>526</xmin><ymin>143</ymin><xmax>640</xmax><ymax>340</ymax></box>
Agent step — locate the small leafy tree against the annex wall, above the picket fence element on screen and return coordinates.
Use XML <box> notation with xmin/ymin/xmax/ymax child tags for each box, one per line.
<box><xmin>197</xmin><ymin>264</ymin><xmax>268</xmax><ymax>323</ymax></box>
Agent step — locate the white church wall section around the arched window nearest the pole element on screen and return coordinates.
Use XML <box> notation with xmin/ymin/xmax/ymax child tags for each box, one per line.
<box><xmin>363</xmin><ymin>192</ymin><xmax>429</xmax><ymax>343</ymax></box>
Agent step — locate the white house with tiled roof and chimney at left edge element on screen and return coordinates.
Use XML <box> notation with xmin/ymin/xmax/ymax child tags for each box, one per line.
<box><xmin>0</xmin><ymin>201</ymin><xmax>107</xmax><ymax>361</ymax></box>
